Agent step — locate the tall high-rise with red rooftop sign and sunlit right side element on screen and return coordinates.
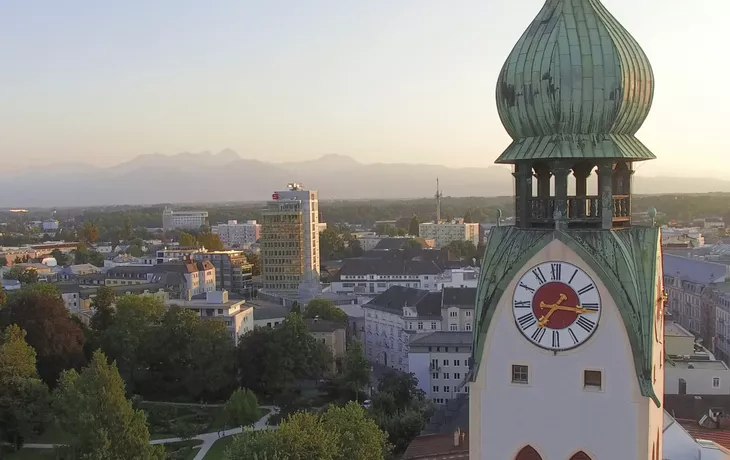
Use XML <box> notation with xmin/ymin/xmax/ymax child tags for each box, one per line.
<box><xmin>259</xmin><ymin>183</ymin><xmax>319</xmax><ymax>293</ymax></box>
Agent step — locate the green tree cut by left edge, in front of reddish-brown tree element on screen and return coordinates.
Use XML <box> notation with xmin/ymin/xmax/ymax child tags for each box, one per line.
<box><xmin>0</xmin><ymin>325</ymin><xmax>50</xmax><ymax>456</ymax></box>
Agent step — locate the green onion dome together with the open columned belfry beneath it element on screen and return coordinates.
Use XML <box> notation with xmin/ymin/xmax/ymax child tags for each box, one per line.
<box><xmin>496</xmin><ymin>0</ymin><xmax>655</xmax><ymax>229</ymax></box>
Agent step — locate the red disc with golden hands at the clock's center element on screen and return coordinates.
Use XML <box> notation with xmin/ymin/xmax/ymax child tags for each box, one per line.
<box><xmin>532</xmin><ymin>282</ymin><xmax>580</xmax><ymax>329</ymax></box>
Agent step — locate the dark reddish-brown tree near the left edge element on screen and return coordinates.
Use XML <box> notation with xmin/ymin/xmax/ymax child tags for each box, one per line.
<box><xmin>0</xmin><ymin>290</ymin><xmax>86</xmax><ymax>386</ymax></box>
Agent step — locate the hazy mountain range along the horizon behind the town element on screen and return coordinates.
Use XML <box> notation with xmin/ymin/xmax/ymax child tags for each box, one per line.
<box><xmin>5</xmin><ymin>149</ymin><xmax>730</xmax><ymax>207</ymax></box>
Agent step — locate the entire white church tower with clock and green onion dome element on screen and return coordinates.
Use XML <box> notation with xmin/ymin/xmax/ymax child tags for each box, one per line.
<box><xmin>469</xmin><ymin>0</ymin><xmax>664</xmax><ymax>460</ymax></box>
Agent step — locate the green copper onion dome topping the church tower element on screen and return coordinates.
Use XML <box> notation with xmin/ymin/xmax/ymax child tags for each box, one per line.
<box><xmin>496</xmin><ymin>0</ymin><xmax>655</xmax><ymax>163</ymax></box>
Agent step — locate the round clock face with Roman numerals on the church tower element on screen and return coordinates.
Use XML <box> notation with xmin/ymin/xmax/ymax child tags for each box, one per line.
<box><xmin>512</xmin><ymin>261</ymin><xmax>601</xmax><ymax>351</ymax></box>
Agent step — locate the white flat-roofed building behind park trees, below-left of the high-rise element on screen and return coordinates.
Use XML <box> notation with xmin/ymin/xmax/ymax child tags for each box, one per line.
<box><xmin>166</xmin><ymin>291</ymin><xmax>254</xmax><ymax>345</ymax></box>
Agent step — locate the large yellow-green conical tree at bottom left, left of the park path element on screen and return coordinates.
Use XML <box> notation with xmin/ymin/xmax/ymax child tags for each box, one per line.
<box><xmin>54</xmin><ymin>351</ymin><xmax>165</xmax><ymax>460</ymax></box>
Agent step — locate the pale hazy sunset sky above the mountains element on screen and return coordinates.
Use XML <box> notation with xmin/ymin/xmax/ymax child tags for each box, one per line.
<box><xmin>0</xmin><ymin>0</ymin><xmax>730</xmax><ymax>177</ymax></box>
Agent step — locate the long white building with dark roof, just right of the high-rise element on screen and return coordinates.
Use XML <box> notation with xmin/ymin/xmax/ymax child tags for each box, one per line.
<box><xmin>330</xmin><ymin>256</ymin><xmax>443</xmax><ymax>297</ymax></box>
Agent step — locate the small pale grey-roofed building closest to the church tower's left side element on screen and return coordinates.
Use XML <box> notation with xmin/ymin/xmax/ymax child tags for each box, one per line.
<box><xmin>408</xmin><ymin>331</ymin><xmax>474</xmax><ymax>404</ymax></box>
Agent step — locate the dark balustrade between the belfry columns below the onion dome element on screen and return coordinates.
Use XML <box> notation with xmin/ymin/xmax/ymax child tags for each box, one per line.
<box><xmin>527</xmin><ymin>195</ymin><xmax>631</xmax><ymax>224</ymax></box>
